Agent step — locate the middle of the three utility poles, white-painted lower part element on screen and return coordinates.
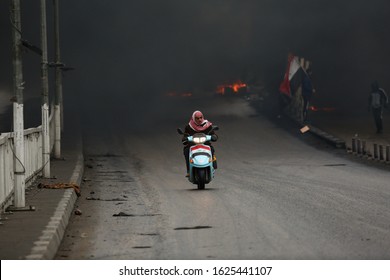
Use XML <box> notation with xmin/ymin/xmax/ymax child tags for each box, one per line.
<box><xmin>41</xmin><ymin>0</ymin><xmax>50</xmax><ymax>178</ymax></box>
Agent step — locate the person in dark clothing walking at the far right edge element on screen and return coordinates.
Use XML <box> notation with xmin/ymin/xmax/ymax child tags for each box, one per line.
<box><xmin>368</xmin><ymin>81</ymin><xmax>389</xmax><ymax>133</ymax></box>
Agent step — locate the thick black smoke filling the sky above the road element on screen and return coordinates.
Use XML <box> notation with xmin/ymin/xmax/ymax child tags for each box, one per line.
<box><xmin>0</xmin><ymin>0</ymin><xmax>390</xmax><ymax>129</ymax></box>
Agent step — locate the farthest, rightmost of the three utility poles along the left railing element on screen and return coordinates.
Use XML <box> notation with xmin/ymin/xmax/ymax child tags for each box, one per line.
<box><xmin>53</xmin><ymin>0</ymin><xmax>64</xmax><ymax>159</ymax></box>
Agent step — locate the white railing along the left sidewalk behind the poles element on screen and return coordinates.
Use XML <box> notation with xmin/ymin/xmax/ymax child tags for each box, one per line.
<box><xmin>0</xmin><ymin>107</ymin><xmax>54</xmax><ymax>214</ymax></box>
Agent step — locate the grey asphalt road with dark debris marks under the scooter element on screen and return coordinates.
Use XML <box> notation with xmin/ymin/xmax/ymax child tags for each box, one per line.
<box><xmin>56</xmin><ymin>98</ymin><xmax>390</xmax><ymax>260</ymax></box>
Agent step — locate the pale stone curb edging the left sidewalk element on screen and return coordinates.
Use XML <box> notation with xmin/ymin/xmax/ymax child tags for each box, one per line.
<box><xmin>25</xmin><ymin>153</ymin><xmax>84</xmax><ymax>260</ymax></box>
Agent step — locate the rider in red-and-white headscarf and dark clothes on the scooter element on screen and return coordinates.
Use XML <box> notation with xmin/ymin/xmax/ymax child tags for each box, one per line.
<box><xmin>182</xmin><ymin>110</ymin><xmax>218</xmax><ymax>177</ymax></box>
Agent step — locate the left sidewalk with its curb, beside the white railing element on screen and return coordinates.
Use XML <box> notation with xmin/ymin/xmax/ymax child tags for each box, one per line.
<box><xmin>0</xmin><ymin>122</ymin><xmax>84</xmax><ymax>260</ymax></box>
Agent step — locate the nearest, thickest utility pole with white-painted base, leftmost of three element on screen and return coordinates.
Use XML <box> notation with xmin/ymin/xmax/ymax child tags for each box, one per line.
<box><xmin>11</xmin><ymin>0</ymin><xmax>26</xmax><ymax>208</ymax></box>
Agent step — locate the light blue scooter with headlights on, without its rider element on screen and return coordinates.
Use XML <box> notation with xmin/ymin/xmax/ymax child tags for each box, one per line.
<box><xmin>177</xmin><ymin>126</ymin><xmax>219</xmax><ymax>190</ymax></box>
